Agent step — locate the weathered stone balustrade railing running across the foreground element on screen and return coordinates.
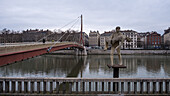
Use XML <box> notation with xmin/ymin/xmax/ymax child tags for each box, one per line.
<box><xmin>0</xmin><ymin>78</ymin><xmax>170</xmax><ymax>95</ymax></box>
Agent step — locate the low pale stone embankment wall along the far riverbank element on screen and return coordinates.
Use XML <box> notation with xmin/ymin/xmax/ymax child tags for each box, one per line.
<box><xmin>52</xmin><ymin>49</ymin><xmax>170</xmax><ymax>55</ymax></box>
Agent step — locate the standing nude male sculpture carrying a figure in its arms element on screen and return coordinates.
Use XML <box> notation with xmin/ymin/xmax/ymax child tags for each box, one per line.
<box><xmin>104</xmin><ymin>26</ymin><xmax>131</xmax><ymax>65</ymax></box>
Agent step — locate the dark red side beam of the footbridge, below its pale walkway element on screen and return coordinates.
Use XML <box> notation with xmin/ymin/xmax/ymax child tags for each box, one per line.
<box><xmin>0</xmin><ymin>44</ymin><xmax>84</xmax><ymax>66</ymax></box>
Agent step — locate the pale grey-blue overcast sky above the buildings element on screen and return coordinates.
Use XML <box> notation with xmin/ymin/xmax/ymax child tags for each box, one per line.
<box><xmin>0</xmin><ymin>0</ymin><xmax>170</xmax><ymax>34</ymax></box>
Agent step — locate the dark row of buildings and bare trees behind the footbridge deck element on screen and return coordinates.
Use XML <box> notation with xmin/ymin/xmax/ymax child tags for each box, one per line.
<box><xmin>0</xmin><ymin>29</ymin><xmax>89</xmax><ymax>46</ymax></box>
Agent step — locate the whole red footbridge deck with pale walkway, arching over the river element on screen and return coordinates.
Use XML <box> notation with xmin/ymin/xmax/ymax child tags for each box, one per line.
<box><xmin>0</xmin><ymin>42</ymin><xmax>84</xmax><ymax>66</ymax></box>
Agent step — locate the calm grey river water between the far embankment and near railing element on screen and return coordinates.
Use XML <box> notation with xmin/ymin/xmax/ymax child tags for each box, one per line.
<box><xmin>0</xmin><ymin>55</ymin><xmax>170</xmax><ymax>78</ymax></box>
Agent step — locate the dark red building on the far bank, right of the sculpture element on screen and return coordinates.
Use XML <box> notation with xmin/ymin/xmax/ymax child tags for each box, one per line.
<box><xmin>147</xmin><ymin>32</ymin><xmax>161</xmax><ymax>49</ymax></box>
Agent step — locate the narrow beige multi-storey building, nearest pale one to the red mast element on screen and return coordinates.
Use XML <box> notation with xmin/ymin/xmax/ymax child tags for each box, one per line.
<box><xmin>89</xmin><ymin>31</ymin><xmax>100</xmax><ymax>46</ymax></box>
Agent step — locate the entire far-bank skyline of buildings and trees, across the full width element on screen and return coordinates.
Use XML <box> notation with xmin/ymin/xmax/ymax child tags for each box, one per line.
<box><xmin>0</xmin><ymin>27</ymin><xmax>170</xmax><ymax>49</ymax></box>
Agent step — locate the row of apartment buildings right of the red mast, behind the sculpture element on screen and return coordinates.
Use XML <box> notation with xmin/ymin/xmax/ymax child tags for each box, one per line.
<box><xmin>89</xmin><ymin>27</ymin><xmax>170</xmax><ymax>49</ymax></box>
